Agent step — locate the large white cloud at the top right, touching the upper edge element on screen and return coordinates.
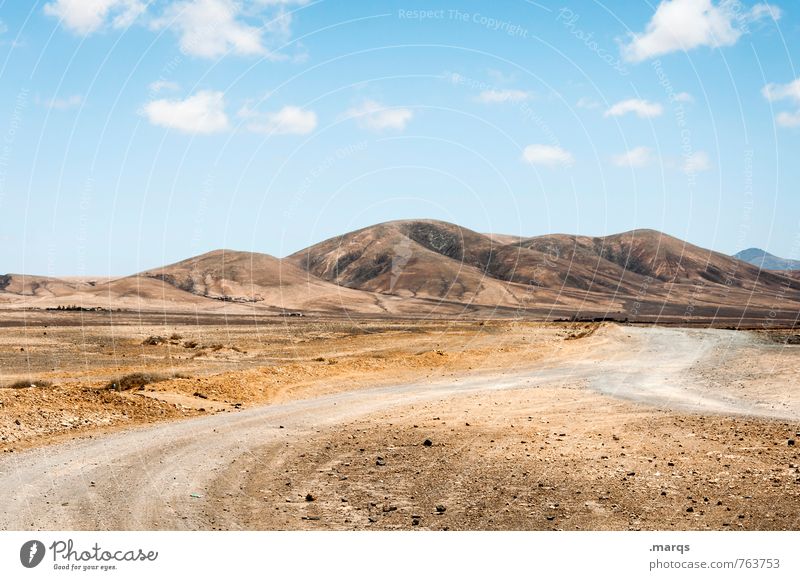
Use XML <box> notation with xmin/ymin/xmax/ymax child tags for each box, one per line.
<box><xmin>622</xmin><ymin>0</ymin><xmax>781</xmax><ymax>62</ymax></box>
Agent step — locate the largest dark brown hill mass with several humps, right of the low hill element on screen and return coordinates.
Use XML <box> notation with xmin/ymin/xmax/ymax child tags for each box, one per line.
<box><xmin>288</xmin><ymin>220</ymin><xmax>800</xmax><ymax>316</ymax></box>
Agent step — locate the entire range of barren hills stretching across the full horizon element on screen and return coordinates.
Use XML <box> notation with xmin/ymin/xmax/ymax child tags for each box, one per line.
<box><xmin>0</xmin><ymin>220</ymin><xmax>800</xmax><ymax>326</ymax></box>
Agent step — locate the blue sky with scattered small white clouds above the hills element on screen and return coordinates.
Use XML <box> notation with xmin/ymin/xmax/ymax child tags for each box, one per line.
<box><xmin>0</xmin><ymin>0</ymin><xmax>800</xmax><ymax>276</ymax></box>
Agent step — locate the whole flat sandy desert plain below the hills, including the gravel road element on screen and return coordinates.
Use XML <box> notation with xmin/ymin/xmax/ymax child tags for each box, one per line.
<box><xmin>0</xmin><ymin>312</ymin><xmax>800</xmax><ymax>530</ymax></box>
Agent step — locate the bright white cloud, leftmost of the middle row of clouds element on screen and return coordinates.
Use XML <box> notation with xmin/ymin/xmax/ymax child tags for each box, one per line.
<box><xmin>143</xmin><ymin>91</ymin><xmax>228</xmax><ymax>134</ymax></box>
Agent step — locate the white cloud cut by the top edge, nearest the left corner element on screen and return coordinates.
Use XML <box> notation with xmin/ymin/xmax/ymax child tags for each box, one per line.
<box><xmin>44</xmin><ymin>0</ymin><xmax>147</xmax><ymax>35</ymax></box>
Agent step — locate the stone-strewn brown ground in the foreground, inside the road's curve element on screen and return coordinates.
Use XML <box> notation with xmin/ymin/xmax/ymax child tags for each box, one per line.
<box><xmin>225</xmin><ymin>386</ymin><xmax>800</xmax><ymax>530</ymax></box>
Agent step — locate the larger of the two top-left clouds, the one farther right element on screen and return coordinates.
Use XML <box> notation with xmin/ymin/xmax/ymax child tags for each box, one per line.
<box><xmin>152</xmin><ymin>0</ymin><xmax>268</xmax><ymax>58</ymax></box>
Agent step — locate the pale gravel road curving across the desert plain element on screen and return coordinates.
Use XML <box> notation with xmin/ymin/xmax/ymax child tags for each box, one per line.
<box><xmin>0</xmin><ymin>327</ymin><xmax>799</xmax><ymax>530</ymax></box>
